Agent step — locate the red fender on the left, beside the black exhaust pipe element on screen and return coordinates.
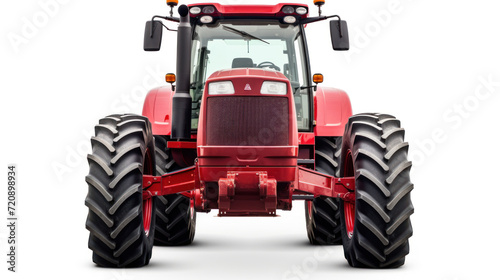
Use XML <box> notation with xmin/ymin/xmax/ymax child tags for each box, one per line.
<box><xmin>142</xmin><ymin>86</ymin><xmax>174</xmax><ymax>135</ymax></box>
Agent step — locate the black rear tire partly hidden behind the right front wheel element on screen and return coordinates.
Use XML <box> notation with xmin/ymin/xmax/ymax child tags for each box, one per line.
<box><xmin>305</xmin><ymin>137</ymin><xmax>342</xmax><ymax>245</ymax></box>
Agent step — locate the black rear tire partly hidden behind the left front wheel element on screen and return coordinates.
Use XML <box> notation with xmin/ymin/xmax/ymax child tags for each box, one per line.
<box><xmin>154</xmin><ymin>135</ymin><xmax>196</xmax><ymax>246</ymax></box>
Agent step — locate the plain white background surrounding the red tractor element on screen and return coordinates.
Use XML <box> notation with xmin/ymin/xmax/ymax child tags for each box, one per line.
<box><xmin>0</xmin><ymin>0</ymin><xmax>500</xmax><ymax>280</ymax></box>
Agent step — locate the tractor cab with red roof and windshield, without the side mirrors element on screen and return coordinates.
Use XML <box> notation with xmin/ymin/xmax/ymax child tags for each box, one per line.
<box><xmin>186</xmin><ymin>4</ymin><xmax>313</xmax><ymax>131</ymax></box>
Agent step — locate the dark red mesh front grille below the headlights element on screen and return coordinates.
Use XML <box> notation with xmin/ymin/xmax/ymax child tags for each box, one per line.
<box><xmin>206</xmin><ymin>96</ymin><xmax>289</xmax><ymax>146</ymax></box>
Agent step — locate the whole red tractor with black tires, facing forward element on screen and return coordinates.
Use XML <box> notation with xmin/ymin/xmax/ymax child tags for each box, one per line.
<box><xmin>85</xmin><ymin>0</ymin><xmax>413</xmax><ymax>268</ymax></box>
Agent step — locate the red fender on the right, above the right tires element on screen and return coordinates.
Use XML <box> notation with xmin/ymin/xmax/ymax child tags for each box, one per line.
<box><xmin>314</xmin><ymin>87</ymin><xmax>352</xmax><ymax>136</ymax></box>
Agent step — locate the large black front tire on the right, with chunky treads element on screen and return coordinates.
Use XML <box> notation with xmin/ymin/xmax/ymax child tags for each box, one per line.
<box><xmin>340</xmin><ymin>114</ymin><xmax>414</xmax><ymax>268</ymax></box>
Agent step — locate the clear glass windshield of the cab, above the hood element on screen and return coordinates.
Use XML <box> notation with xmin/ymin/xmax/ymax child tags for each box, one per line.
<box><xmin>191</xmin><ymin>20</ymin><xmax>310</xmax><ymax>130</ymax></box>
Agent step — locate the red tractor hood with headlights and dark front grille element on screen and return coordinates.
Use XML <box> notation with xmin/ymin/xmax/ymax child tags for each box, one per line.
<box><xmin>197</xmin><ymin>65</ymin><xmax>298</xmax><ymax>166</ymax></box>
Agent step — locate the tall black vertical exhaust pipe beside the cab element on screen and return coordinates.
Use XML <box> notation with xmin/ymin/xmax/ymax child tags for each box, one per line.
<box><xmin>171</xmin><ymin>5</ymin><xmax>192</xmax><ymax>140</ymax></box>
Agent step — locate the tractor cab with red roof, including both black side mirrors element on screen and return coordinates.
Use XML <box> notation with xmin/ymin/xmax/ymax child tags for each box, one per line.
<box><xmin>144</xmin><ymin>1</ymin><xmax>349</xmax><ymax>139</ymax></box>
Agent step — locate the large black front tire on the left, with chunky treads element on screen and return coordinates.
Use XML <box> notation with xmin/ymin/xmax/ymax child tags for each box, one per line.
<box><xmin>85</xmin><ymin>115</ymin><xmax>155</xmax><ymax>267</ymax></box>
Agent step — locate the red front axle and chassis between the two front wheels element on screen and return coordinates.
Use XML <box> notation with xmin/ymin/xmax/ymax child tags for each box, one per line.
<box><xmin>143</xmin><ymin>149</ymin><xmax>355</xmax><ymax>216</ymax></box>
